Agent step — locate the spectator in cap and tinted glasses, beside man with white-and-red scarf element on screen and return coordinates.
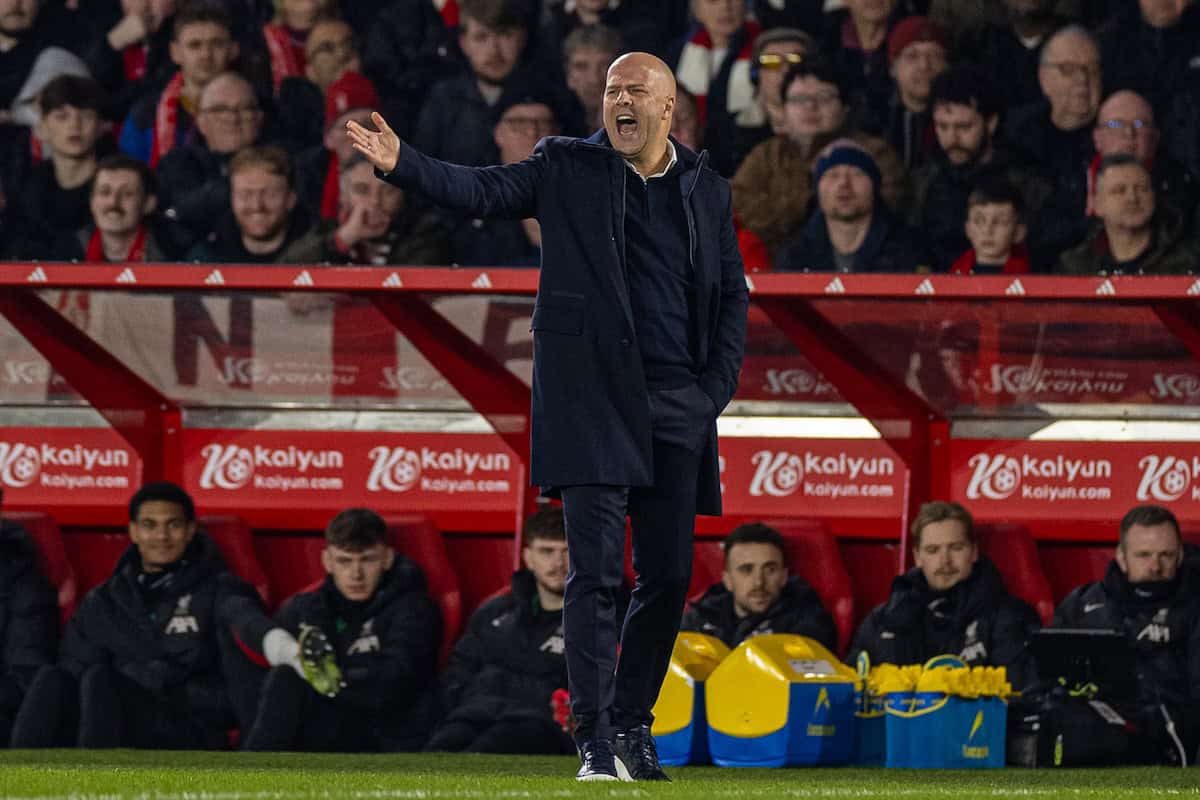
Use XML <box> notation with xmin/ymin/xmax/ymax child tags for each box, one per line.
<box><xmin>733</xmin><ymin>28</ymin><xmax>817</xmax><ymax>170</ymax></box>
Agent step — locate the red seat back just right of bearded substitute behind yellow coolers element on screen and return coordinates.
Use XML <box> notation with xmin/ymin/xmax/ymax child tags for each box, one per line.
<box><xmin>763</xmin><ymin>517</ymin><xmax>854</xmax><ymax>655</ymax></box>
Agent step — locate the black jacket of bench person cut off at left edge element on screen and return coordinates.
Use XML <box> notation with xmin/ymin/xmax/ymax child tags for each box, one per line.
<box><xmin>0</xmin><ymin>521</ymin><xmax>59</xmax><ymax>718</ymax></box>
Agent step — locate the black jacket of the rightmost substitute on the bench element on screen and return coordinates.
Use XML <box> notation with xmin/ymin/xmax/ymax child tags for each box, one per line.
<box><xmin>1051</xmin><ymin>561</ymin><xmax>1200</xmax><ymax>714</ymax></box>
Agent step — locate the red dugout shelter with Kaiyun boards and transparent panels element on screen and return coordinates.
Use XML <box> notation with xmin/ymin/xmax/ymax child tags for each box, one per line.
<box><xmin>0</xmin><ymin>264</ymin><xmax>1200</xmax><ymax>614</ymax></box>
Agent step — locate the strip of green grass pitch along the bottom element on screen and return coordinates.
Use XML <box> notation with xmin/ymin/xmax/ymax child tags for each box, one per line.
<box><xmin>0</xmin><ymin>750</ymin><xmax>1200</xmax><ymax>800</ymax></box>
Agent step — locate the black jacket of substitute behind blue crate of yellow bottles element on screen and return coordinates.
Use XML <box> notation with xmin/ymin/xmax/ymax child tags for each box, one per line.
<box><xmin>846</xmin><ymin>555</ymin><xmax>1038</xmax><ymax>688</ymax></box>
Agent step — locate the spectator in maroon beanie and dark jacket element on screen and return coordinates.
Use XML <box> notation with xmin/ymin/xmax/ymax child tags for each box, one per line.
<box><xmin>854</xmin><ymin>17</ymin><xmax>950</xmax><ymax>169</ymax></box>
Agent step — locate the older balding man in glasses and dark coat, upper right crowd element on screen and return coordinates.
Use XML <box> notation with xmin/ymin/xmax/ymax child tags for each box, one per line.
<box><xmin>1004</xmin><ymin>25</ymin><xmax>1100</xmax><ymax>264</ymax></box>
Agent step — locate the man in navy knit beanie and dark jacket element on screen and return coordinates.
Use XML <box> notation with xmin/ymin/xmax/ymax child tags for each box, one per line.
<box><xmin>775</xmin><ymin>139</ymin><xmax>929</xmax><ymax>272</ymax></box>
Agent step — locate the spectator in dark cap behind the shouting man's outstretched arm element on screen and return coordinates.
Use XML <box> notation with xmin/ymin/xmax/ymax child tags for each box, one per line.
<box><xmin>451</xmin><ymin>96</ymin><xmax>559</xmax><ymax>266</ymax></box>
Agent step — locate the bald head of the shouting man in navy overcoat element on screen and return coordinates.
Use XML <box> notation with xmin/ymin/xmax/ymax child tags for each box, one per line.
<box><xmin>604</xmin><ymin>53</ymin><xmax>676</xmax><ymax>175</ymax></box>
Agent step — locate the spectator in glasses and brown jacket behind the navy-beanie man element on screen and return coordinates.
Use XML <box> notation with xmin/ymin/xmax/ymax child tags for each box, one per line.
<box><xmin>733</xmin><ymin>60</ymin><xmax>907</xmax><ymax>257</ymax></box>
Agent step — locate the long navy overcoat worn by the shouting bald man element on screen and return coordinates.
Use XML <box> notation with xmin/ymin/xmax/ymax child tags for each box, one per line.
<box><xmin>377</xmin><ymin>130</ymin><xmax>748</xmax><ymax>515</ymax></box>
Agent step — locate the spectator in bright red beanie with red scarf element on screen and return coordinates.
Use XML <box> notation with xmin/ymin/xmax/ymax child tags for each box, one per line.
<box><xmin>296</xmin><ymin>72</ymin><xmax>379</xmax><ymax>221</ymax></box>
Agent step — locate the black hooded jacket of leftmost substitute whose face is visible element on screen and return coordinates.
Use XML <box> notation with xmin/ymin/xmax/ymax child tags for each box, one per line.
<box><xmin>59</xmin><ymin>531</ymin><xmax>274</xmax><ymax>732</ymax></box>
